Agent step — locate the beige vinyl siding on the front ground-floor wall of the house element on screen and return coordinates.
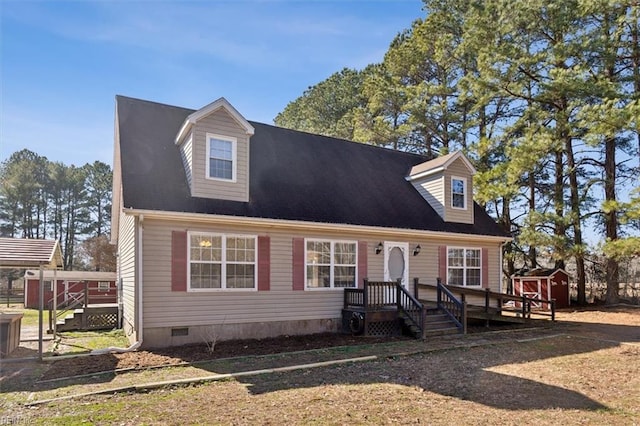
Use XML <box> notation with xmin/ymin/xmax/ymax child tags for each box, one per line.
<box><xmin>143</xmin><ymin>218</ymin><xmax>498</xmax><ymax>328</ymax></box>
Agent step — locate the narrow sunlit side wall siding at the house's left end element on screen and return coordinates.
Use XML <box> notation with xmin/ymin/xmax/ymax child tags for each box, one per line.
<box><xmin>118</xmin><ymin>213</ymin><xmax>136</xmax><ymax>325</ymax></box>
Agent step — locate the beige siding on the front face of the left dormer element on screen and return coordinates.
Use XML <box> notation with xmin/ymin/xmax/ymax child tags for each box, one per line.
<box><xmin>191</xmin><ymin>109</ymin><xmax>249</xmax><ymax>201</ymax></box>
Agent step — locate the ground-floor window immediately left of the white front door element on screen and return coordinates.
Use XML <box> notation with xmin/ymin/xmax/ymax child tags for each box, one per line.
<box><xmin>305</xmin><ymin>240</ymin><xmax>357</xmax><ymax>289</ymax></box>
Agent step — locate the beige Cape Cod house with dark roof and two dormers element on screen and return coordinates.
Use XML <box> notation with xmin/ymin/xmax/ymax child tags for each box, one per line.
<box><xmin>112</xmin><ymin>96</ymin><xmax>509</xmax><ymax>347</ymax></box>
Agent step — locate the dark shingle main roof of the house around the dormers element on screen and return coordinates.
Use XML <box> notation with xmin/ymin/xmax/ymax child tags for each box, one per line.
<box><xmin>117</xmin><ymin>96</ymin><xmax>504</xmax><ymax>236</ymax></box>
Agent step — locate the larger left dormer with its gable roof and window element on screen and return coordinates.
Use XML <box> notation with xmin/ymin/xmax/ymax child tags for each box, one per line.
<box><xmin>176</xmin><ymin>98</ymin><xmax>254</xmax><ymax>202</ymax></box>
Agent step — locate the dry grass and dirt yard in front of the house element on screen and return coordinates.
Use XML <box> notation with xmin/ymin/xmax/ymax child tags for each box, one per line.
<box><xmin>0</xmin><ymin>307</ymin><xmax>640</xmax><ymax>425</ymax></box>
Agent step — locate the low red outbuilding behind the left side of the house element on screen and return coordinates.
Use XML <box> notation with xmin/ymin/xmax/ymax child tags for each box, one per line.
<box><xmin>24</xmin><ymin>270</ymin><xmax>118</xmax><ymax>309</ymax></box>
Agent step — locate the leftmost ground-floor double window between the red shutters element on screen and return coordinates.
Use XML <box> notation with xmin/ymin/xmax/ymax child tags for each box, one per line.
<box><xmin>189</xmin><ymin>232</ymin><xmax>257</xmax><ymax>291</ymax></box>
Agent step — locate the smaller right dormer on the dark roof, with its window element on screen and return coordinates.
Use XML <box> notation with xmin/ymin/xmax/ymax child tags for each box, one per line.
<box><xmin>406</xmin><ymin>151</ymin><xmax>476</xmax><ymax>224</ymax></box>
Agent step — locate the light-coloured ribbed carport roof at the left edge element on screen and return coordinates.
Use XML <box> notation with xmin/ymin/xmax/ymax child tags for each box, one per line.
<box><xmin>0</xmin><ymin>238</ymin><xmax>63</xmax><ymax>269</ymax></box>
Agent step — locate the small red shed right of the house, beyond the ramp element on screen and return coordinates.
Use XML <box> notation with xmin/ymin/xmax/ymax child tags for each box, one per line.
<box><xmin>511</xmin><ymin>268</ymin><xmax>570</xmax><ymax>309</ymax></box>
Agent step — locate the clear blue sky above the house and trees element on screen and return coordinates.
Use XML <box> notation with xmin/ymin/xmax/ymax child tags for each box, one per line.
<box><xmin>0</xmin><ymin>0</ymin><xmax>424</xmax><ymax>166</ymax></box>
